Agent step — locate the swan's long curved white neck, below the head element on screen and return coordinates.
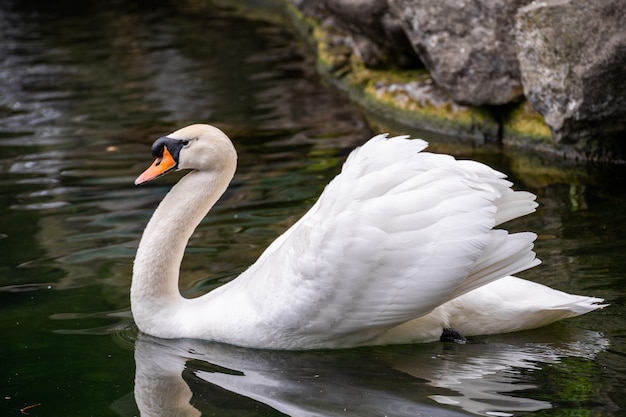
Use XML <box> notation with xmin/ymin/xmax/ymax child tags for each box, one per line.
<box><xmin>131</xmin><ymin>167</ymin><xmax>234</xmax><ymax>336</ymax></box>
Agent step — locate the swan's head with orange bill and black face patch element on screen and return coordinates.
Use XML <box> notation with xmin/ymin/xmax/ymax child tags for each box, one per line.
<box><xmin>135</xmin><ymin>124</ymin><xmax>237</xmax><ymax>185</ymax></box>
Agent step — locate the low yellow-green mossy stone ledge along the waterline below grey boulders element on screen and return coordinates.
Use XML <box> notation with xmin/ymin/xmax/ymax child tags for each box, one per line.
<box><xmin>285</xmin><ymin>2</ymin><xmax>551</xmax><ymax>146</ymax></box>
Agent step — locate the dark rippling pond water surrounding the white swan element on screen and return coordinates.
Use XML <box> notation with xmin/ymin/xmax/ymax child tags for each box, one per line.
<box><xmin>0</xmin><ymin>0</ymin><xmax>626</xmax><ymax>416</ymax></box>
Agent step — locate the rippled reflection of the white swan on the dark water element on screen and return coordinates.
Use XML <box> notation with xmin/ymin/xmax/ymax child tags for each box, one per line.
<box><xmin>135</xmin><ymin>332</ymin><xmax>608</xmax><ymax>417</ymax></box>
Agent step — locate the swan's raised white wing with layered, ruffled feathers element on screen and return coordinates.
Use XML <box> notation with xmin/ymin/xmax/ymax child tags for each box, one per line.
<box><xmin>229</xmin><ymin>135</ymin><xmax>536</xmax><ymax>346</ymax></box>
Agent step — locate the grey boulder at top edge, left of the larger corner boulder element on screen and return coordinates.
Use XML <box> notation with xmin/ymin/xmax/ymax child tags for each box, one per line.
<box><xmin>389</xmin><ymin>0</ymin><xmax>530</xmax><ymax>105</ymax></box>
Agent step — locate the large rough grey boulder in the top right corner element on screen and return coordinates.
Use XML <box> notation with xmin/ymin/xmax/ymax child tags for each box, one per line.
<box><xmin>515</xmin><ymin>0</ymin><xmax>626</xmax><ymax>144</ymax></box>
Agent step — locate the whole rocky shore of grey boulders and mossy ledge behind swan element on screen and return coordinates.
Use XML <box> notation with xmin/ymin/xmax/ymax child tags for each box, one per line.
<box><xmin>285</xmin><ymin>0</ymin><xmax>626</xmax><ymax>161</ymax></box>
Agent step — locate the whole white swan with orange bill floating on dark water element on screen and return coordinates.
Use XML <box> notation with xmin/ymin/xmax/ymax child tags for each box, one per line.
<box><xmin>131</xmin><ymin>125</ymin><xmax>603</xmax><ymax>349</ymax></box>
